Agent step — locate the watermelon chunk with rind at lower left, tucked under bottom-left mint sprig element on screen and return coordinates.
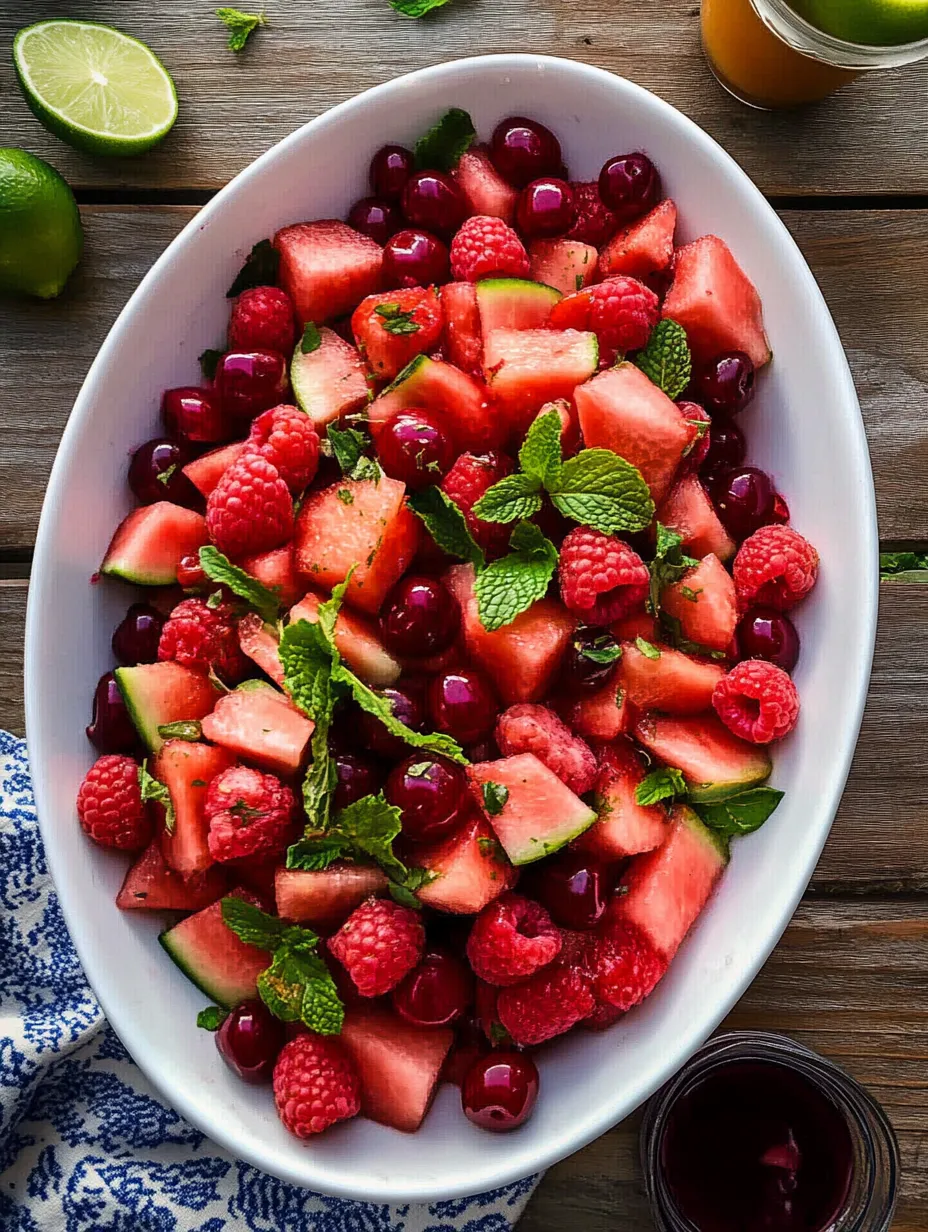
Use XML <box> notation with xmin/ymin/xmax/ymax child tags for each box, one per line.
<box><xmin>158</xmin><ymin>888</ymin><xmax>271</xmax><ymax>1009</ymax></box>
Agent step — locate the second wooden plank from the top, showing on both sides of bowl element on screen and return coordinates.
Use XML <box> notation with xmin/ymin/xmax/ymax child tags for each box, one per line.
<box><xmin>0</xmin><ymin>206</ymin><xmax>928</xmax><ymax>549</ymax></box>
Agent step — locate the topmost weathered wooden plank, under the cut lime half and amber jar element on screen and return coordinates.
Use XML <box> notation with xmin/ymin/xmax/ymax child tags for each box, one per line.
<box><xmin>0</xmin><ymin>0</ymin><xmax>928</xmax><ymax>195</ymax></box>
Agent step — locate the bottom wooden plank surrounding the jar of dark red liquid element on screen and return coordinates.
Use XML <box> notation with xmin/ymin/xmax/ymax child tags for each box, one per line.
<box><xmin>519</xmin><ymin>899</ymin><xmax>928</xmax><ymax>1232</ymax></box>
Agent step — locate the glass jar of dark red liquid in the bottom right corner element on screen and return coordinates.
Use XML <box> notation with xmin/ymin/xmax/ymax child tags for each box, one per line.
<box><xmin>641</xmin><ymin>1031</ymin><xmax>900</xmax><ymax>1232</ymax></box>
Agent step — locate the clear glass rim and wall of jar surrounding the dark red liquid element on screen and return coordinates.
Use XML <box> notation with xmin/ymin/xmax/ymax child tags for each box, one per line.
<box><xmin>641</xmin><ymin>1031</ymin><xmax>900</xmax><ymax>1232</ymax></box>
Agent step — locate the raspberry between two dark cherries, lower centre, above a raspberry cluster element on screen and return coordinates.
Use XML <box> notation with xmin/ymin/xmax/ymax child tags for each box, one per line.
<box><xmin>467</xmin><ymin>894</ymin><xmax>561</xmax><ymax>986</ymax></box>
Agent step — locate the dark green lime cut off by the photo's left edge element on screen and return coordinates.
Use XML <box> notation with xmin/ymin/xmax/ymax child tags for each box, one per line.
<box><xmin>0</xmin><ymin>149</ymin><xmax>83</xmax><ymax>299</ymax></box>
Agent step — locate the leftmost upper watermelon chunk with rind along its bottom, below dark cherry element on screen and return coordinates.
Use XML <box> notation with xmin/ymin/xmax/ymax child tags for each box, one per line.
<box><xmin>100</xmin><ymin>500</ymin><xmax>210</xmax><ymax>586</ymax></box>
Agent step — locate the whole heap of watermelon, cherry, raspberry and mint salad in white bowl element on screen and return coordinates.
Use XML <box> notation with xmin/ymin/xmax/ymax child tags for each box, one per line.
<box><xmin>78</xmin><ymin>110</ymin><xmax>818</xmax><ymax>1138</ymax></box>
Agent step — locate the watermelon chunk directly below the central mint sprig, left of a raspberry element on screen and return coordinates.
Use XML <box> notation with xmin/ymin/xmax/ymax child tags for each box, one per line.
<box><xmin>444</xmin><ymin>564</ymin><xmax>577</xmax><ymax>705</ymax></box>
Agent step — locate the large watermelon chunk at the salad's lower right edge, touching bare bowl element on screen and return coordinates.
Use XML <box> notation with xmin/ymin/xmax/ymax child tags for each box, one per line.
<box><xmin>615</xmin><ymin>806</ymin><xmax>728</xmax><ymax>958</ymax></box>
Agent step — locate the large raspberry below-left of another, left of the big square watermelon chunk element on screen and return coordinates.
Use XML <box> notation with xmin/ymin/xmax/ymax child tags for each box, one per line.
<box><xmin>206</xmin><ymin>453</ymin><xmax>293</xmax><ymax>558</ymax></box>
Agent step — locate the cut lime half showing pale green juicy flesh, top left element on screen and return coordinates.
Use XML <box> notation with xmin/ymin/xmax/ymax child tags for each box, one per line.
<box><xmin>12</xmin><ymin>21</ymin><xmax>177</xmax><ymax>154</ymax></box>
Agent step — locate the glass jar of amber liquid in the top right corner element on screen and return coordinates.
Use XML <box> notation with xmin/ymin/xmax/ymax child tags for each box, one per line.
<box><xmin>701</xmin><ymin>0</ymin><xmax>928</xmax><ymax>108</ymax></box>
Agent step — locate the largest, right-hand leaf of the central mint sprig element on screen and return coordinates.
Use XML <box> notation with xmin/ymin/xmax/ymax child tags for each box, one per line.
<box><xmin>548</xmin><ymin>450</ymin><xmax>654</xmax><ymax>535</ymax></box>
